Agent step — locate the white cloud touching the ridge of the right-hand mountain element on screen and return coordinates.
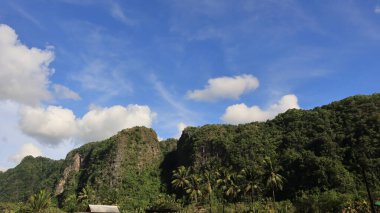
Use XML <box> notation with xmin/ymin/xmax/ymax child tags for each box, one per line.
<box><xmin>222</xmin><ymin>94</ymin><xmax>300</xmax><ymax>124</ymax></box>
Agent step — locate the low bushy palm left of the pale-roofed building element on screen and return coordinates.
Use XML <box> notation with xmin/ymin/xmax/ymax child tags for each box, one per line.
<box><xmin>27</xmin><ymin>190</ymin><xmax>51</xmax><ymax>213</ymax></box>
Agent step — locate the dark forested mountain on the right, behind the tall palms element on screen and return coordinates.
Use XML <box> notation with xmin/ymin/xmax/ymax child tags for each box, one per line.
<box><xmin>174</xmin><ymin>94</ymin><xmax>380</xmax><ymax>200</ymax></box>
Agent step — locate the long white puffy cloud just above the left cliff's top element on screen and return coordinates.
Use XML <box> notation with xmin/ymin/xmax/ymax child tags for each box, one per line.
<box><xmin>20</xmin><ymin>105</ymin><xmax>156</xmax><ymax>145</ymax></box>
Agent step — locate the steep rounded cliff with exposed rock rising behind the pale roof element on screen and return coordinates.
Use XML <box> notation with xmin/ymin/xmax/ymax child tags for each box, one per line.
<box><xmin>55</xmin><ymin>127</ymin><xmax>162</xmax><ymax>208</ymax></box>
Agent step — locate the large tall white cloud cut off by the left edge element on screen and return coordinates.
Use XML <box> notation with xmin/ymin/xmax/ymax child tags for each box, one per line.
<box><xmin>0</xmin><ymin>24</ymin><xmax>54</xmax><ymax>105</ymax></box>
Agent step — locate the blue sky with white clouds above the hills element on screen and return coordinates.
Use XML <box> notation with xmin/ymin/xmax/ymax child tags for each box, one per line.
<box><xmin>0</xmin><ymin>0</ymin><xmax>380</xmax><ymax>171</ymax></box>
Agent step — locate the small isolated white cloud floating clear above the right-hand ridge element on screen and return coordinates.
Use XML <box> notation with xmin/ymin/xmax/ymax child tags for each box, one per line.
<box><xmin>187</xmin><ymin>75</ymin><xmax>259</xmax><ymax>101</ymax></box>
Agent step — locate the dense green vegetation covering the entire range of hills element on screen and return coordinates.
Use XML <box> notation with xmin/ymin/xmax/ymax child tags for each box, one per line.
<box><xmin>0</xmin><ymin>94</ymin><xmax>380</xmax><ymax>212</ymax></box>
